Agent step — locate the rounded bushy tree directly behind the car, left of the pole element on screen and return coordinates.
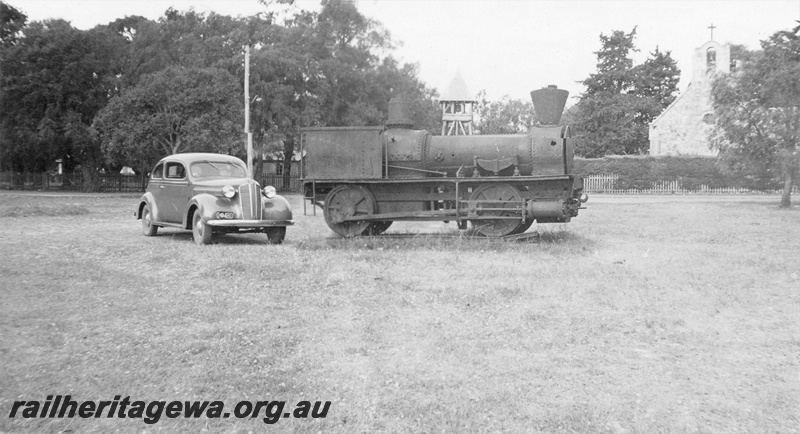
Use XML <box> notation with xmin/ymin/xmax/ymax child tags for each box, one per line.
<box><xmin>94</xmin><ymin>67</ymin><xmax>243</xmax><ymax>170</ymax></box>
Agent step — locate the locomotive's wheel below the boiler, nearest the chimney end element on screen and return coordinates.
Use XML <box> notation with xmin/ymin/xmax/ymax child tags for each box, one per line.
<box><xmin>469</xmin><ymin>184</ymin><xmax>530</xmax><ymax>237</ymax></box>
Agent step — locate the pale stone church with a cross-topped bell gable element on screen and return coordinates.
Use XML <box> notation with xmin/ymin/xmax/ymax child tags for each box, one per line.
<box><xmin>650</xmin><ymin>36</ymin><xmax>731</xmax><ymax>156</ymax></box>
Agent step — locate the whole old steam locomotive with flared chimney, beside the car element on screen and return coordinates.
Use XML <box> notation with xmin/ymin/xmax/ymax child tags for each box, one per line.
<box><xmin>301</xmin><ymin>86</ymin><xmax>587</xmax><ymax>237</ymax></box>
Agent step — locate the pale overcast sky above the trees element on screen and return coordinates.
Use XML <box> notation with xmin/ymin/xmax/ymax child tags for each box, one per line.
<box><xmin>3</xmin><ymin>0</ymin><xmax>800</xmax><ymax>102</ymax></box>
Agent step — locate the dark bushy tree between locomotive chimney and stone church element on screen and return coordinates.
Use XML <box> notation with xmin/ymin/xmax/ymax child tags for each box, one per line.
<box><xmin>571</xmin><ymin>28</ymin><xmax>680</xmax><ymax>157</ymax></box>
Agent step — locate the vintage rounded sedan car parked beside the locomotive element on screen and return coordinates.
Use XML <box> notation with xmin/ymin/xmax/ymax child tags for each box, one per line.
<box><xmin>134</xmin><ymin>153</ymin><xmax>294</xmax><ymax>244</ymax></box>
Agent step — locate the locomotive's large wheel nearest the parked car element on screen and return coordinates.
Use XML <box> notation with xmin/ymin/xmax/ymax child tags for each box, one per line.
<box><xmin>325</xmin><ymin>185</ymin><xmax>375</xmax><ymax>238</ymax></box>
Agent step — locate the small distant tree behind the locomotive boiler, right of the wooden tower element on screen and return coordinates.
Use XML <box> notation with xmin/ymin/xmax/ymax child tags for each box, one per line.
<box><xmin>476</xmin><ymin>91</ymin><xmax>537</xmax><ymax>134</ymax></box>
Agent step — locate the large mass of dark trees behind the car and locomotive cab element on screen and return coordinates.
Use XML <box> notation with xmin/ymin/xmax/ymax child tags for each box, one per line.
<box><xmin>0</xmin><ymin>0</ymin><xmax>439</xmax><ymax>190</ymax></box>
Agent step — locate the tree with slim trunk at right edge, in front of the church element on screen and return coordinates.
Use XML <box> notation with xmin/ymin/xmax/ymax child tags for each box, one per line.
<box><xmin>711</xmin><ymin>22</ymin><xmax>800</xmax><ymax>208</ymax></box>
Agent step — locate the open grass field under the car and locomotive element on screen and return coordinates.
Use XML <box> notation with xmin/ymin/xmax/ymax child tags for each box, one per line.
<box><xmin>0</xmin><ymin>193</ymin><xmax>800</xmax><ymax>433</ymax></box>
